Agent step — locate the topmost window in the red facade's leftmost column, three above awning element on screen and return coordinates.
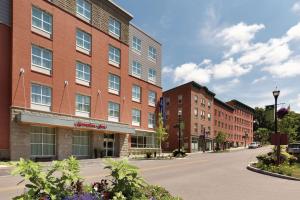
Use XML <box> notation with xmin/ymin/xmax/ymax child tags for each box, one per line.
<box><xmin>32</xmin><ymin>7</ymin><xmax>52</xmax><ymax>37</ymax></box>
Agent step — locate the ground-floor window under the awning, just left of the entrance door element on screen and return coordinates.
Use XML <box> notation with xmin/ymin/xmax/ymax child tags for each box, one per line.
<box><xmin>72</xmin><ymin>131</ymin><xmax>90</xmax><ymax>156</ymax></box>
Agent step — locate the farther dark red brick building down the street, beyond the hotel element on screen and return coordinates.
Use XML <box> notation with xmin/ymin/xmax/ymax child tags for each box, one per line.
<box><xmin>163</xmin><ymin>81</ymin><xmax>254</xmax><ymax>152</ymax></box>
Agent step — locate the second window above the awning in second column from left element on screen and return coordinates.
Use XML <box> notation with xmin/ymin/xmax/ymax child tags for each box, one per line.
<box><xmin>76</xmin><ymin>62</ymin><xmax>91</xmax><ymax>86</ymax></box>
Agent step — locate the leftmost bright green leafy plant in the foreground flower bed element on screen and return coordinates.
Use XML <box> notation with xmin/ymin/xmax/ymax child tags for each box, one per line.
<box><xmin>12</xmin><ymin>157</ymin><xmax>81</xmax><ymax>200</ymax></box>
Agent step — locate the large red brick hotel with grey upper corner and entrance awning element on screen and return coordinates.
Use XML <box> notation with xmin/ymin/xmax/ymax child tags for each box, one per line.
<box><xmin>0</xmin><ymin>0</ymin><xmax>162</xmax><ymax>160</ymax></box>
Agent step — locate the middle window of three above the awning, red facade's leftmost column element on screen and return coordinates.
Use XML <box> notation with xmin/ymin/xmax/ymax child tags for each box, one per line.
<box><xmin>31</xmin><ymin>45</ymin><xmax>52</xmax><ymax>75</ymax></box>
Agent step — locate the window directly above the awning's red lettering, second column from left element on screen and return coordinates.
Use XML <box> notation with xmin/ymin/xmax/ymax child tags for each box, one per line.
<box><xmin>76</xmin><ymin>94</ymin><xmax>91</xmax><ymax>117</ymax></box>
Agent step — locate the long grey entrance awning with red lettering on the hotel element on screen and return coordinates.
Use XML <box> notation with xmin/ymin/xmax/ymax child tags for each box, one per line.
<box><xmin>16</xmin><ymin>111</ymin><xmax>135</xmax><ymax>134</ymax></box>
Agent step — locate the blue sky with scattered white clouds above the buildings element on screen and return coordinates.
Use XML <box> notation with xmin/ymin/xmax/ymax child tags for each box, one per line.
<box><xmin>115</xmin><ymin>0</ymin><xmax>300</xmax><ymax>112</ymax></box>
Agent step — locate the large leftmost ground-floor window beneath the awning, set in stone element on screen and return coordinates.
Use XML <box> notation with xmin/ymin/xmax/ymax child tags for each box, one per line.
<box><xmin>30</xmin><ymin>126</ymin><xmax>56</xmax><ymax>157</ymax></box>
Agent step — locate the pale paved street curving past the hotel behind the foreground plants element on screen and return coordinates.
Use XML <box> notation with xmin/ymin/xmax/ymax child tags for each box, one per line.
<box><xmin>0</xmin><ymin>148</ymin><xmax>300</xmax><ymax>200</ymax></box>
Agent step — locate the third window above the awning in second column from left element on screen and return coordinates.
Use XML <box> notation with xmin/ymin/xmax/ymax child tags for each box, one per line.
<box><xmin>76</xmin><ymin>29</ymin><xmax>91</xmax><ymax>54</ymax></box>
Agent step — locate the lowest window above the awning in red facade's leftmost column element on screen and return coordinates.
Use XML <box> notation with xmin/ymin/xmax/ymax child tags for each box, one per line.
<box><xmin>31</xmin><ymin>84</ymin><xmax>52</xmax><ymax>111</ymax></box>
